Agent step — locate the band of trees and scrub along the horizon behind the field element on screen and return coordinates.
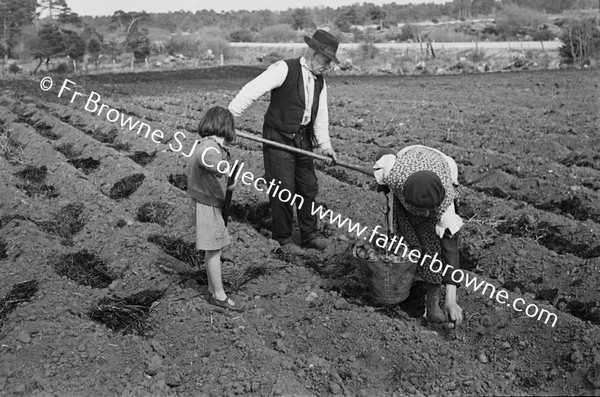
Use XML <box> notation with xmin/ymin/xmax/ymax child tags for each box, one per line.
<box><xmin>0</xmin><ymin>0</ymin><xmax>598</xmax><ymax>70</ymax></box>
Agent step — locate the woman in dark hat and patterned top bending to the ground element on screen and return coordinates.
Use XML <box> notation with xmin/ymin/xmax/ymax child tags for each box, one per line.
<box><xmin>374</xmin><ymin>145</ymin><xmax>463</xmax><ymax>325</ymax></box>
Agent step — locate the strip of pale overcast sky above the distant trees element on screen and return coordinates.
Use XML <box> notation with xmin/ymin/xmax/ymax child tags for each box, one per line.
<box><xmin>67</xmin><ymin>0</ymin><xmax>451</xmax><ymax>16</ymax></box>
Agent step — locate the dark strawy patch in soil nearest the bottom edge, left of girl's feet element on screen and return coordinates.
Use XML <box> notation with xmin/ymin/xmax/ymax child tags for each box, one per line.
<box><xmin>88</xmin><ymin>289</ymin><xmax>165</xmax><ymax>335</ymax></box>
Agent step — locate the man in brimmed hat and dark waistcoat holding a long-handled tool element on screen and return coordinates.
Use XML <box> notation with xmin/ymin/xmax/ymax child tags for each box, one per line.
<box><xmin>229</xmin><ymin>30</ymin><xmax>339</xmax><ymax>255</ymax></box>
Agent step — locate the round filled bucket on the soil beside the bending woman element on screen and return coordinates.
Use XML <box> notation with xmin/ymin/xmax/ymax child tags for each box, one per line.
<box><xmin>352</xmin><ymin>245</ymin><xmax>417</xmax><ymax>305</ymax></box>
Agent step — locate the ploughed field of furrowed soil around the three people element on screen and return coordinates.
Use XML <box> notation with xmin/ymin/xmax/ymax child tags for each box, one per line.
<box><xmin>0</xmin><ymin>67</ymin><xmax>600</xmax><ymax>396</ymax></box>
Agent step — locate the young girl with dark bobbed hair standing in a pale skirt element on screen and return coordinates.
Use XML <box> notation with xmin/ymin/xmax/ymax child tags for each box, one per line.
<box><xmin>187</xmin><ymin>106</ymin><xmax>245</xmax><ymax>311</ymax></box>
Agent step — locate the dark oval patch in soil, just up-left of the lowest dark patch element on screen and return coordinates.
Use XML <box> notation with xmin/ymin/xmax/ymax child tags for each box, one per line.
<box><xmin>52</xmin><ymin>250</ymin><xmax>113</xmax><ymax>288</ymax></box>
